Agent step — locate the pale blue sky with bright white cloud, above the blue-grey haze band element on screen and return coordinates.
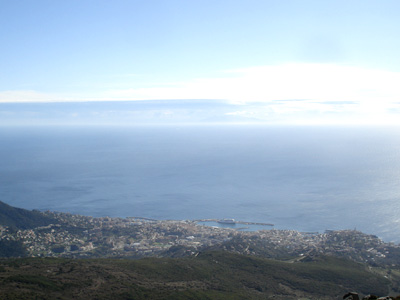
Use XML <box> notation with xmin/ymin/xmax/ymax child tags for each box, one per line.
<box><xmin>0</xmin><ymin>0</ymin><xmax>400</xmax><ymax>125</ymax></box>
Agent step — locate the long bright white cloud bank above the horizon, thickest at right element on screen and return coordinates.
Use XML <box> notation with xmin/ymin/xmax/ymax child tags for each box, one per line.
<box><xmin>0</xmin><ymin>64</ymin><xmax>400</xmax><ymax>123</ymax></box>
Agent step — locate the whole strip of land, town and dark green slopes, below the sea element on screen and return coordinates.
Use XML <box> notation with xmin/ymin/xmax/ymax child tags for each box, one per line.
<box><xmin>0</xmin><ymin>202</ymin><xmax>400</xmax><ymax>300</ymax></box>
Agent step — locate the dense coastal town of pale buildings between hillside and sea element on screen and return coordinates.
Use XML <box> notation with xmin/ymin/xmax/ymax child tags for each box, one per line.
<box><xmin>0</xmin><ymin>211</ymin><xmax>400</xmax><ymax>265</ymax></box>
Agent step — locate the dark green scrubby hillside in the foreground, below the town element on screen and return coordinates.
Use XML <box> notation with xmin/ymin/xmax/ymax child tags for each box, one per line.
<box><xmin>0</xmin><ymin>252</ymin><xmax>389</xmax><ymax>299</ymax></box>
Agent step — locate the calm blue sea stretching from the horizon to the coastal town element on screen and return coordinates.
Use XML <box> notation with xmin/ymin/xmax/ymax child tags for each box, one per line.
<box><xmin>0</xmin><ymin>125</ymin><xmax>400</xmax><ymax>242</ymax></box>
